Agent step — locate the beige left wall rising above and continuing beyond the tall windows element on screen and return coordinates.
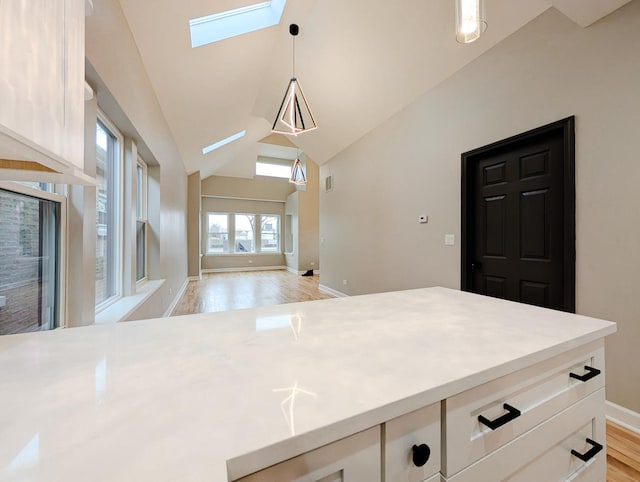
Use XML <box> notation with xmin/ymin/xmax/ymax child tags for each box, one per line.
<box><xmin>86</xmin><ymin>0</ymin><xmax>187</xmax><ymax>316</ymax></box>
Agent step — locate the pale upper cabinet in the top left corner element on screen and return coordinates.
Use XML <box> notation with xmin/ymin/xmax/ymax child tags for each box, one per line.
<box><xmin>0</xmin><ymin>0</ymin><xmax>90</xmax><ymax>182</ymax></box>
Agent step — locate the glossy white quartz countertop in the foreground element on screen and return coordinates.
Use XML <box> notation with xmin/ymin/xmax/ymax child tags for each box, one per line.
<box><xmin>0</xmin><ymin>288</ymin><xmax>615</xmax><ymax>482</ymax></box>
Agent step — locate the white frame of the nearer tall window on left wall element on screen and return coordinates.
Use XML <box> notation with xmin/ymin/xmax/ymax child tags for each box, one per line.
<box><xmin>95</xmin><ymin>108</ymin><xmax>124</xmax><ymax>313</ymax></box>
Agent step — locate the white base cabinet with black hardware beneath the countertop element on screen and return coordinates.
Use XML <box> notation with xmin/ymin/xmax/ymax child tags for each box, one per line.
<box><xmin>239</xmin><ymin>339</ymin><xmax>606</xmax><ymax>482</ymax></box>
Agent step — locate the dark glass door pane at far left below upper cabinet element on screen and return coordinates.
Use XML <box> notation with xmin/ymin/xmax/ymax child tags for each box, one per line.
<box><xmin>0</xmin><ymin>189</ymin><xmax>61</xmax><ymax>335</ymax></box>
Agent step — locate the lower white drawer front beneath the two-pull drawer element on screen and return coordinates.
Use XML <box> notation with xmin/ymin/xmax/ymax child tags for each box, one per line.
<box><xmin>446</xmin><ymin>389</ymin><xmax>607</xmax><ymax>482</ymax></box>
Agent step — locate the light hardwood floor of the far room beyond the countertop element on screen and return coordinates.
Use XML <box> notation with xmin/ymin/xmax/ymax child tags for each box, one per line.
<box><xmin>171</xmin><ymin>270</ymin><xmax>333</xmax><ymax>316</ymax></box>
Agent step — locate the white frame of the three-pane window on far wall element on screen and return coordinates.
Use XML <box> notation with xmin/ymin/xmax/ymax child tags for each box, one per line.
<box><xmin>202</xmin><ymin>211</ymin><xmax>284</xmax><ymax>256</ymax></box>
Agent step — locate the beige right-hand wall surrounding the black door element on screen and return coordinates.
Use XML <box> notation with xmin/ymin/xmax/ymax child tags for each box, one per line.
<box><xmin>320</xmin><ymin>0</ymin><xmax>640</xmax><ymax>411</ymax></box>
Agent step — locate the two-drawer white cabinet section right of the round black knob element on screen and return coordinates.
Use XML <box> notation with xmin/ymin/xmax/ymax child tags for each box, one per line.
<box><xmin>442</xmin><ymin>340</ymin><xmax>606</xmax><ymax>482</ymax></box>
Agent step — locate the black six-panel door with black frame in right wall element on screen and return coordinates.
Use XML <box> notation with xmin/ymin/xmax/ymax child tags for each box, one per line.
<box><xmin>463</xmin><ymin>118</ymin><xmax>575</xmax><ymax>311</ymax></box>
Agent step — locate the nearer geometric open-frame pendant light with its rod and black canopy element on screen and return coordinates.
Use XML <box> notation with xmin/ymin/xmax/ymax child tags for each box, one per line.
<box><xmin>271</xmin><ymin>23</ymin><xmax>318</xmax><ymax>137</ymax></box>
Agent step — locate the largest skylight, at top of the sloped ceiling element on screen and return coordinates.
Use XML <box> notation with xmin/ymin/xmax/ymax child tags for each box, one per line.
<box><xmin>189</xmin><ymin>0</ymin><xmax>287</xmax><ymax>48</ymax></box>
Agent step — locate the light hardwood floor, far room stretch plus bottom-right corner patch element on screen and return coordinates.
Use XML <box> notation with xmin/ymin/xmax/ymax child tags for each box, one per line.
<box><xmin>172</xmin><ymin>270</ymin><xmax>640</xmax><ymax>482</ymax></box>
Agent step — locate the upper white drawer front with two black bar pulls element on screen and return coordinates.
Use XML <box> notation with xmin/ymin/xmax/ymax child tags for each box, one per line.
<box><xmin>443</xmin><ymin>340</ymin><xmax>604</xmax><ymax>476</ymax></box>
